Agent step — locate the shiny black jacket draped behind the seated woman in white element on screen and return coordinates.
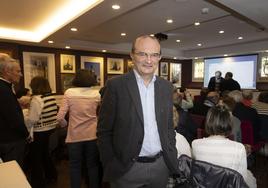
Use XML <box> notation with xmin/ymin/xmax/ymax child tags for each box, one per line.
<box><xmin>175</xmin><ymin>155</ymin><xmax>248</xmax><ymax>188</ymax></box>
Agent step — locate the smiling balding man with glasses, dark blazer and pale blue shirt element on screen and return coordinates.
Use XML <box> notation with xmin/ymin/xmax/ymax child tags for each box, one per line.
<box><xmin>97</xmin><ymin>36</ymin><xmax>177</xmax><ymax>188</ymax></box>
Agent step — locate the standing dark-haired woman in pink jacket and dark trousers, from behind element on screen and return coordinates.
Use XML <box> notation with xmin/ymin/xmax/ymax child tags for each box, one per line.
<box><xmin>58</xmin><ymin>70</ymin><xmax>101</xmax><ymax>188</ymax></box>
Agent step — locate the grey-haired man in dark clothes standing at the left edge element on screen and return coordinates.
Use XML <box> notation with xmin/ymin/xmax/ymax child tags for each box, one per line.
<box><xmin>0</xmin><ymin>53</ymin><xmax>29</xmax><ymax>165</ymax></box>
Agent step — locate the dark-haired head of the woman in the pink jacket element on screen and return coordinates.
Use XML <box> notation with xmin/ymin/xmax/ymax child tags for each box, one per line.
<box><xmin>72</xmin><ymin>69</ymin><xmax>97</xmax><ymax>87</ymax></box>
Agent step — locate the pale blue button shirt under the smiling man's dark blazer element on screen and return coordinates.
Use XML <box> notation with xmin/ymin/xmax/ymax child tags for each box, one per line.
<box><xmin>134</xmin><ymin>70</ymin><xmax>162</xmax><ymax>156</ymax></box>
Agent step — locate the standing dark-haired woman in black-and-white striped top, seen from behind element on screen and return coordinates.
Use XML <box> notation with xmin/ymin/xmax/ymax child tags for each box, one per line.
<box><xmin>29</xmin><ymin>76</ymin><xmax>57</xmax><ymax>188</ymax></box>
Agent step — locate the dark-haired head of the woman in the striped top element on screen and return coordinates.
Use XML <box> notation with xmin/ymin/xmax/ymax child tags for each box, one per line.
<box><xmin>30</xmin><ymin>76</ymin><xmax>51</xmax><ymax>95</ymax></box>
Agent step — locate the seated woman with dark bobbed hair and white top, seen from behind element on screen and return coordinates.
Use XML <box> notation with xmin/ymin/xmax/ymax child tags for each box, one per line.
<box><xmin>192</xmin><ymin>105</ymin><xmax>257</xmax><ymax>188</ymax></box>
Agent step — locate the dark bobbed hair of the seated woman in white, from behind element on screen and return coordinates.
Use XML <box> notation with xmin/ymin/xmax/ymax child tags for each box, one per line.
<box><xmin>205</xmin><ymin>105</ymin><xmax>232</xmax><ymax>136</ymax></box>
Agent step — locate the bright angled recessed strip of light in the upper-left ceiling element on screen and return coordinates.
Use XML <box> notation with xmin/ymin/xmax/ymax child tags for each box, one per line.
<box><xmin>0</xmin><ymin>0</ymin><xmax>103</xmax><ymax>42</ymax></box>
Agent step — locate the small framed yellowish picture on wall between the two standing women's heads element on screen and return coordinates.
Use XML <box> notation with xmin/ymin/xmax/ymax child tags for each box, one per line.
<box><xmin>60</xmin><ymin>54</ymin><xmax>75</xmax><ymax>73</ymax></box>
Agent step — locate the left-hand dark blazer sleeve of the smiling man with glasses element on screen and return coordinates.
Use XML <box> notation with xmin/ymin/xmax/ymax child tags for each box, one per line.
<box><xmin>97</xmin><ymin>81</ymin><xmax>117</xmax><ymax>166</ymax></box>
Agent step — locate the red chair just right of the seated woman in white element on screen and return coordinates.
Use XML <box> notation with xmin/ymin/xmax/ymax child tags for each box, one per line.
<box><xmin>241</xmin><ymin>120</ymin><xmax>265</xmax><ymax>152</ymax></box>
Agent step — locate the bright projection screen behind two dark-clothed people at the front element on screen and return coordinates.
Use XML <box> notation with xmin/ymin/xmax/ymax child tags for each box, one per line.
<box><xmin>204</xmin><ymin>55</ymin><xmax>258</xmax><ymax>89</ymax></box>
